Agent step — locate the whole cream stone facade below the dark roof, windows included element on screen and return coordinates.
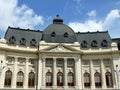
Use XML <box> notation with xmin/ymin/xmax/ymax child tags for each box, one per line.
<box><xmin>0</xmin><ymin>15</ymin><xmax>120</xmax><ymax>90</ymax></box>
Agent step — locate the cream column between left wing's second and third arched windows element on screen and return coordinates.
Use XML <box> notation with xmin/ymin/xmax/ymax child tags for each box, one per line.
<box><xmin>24</xmin><ymin>58</ymin><xmax>29</xmax><ymax>89</ymax></box>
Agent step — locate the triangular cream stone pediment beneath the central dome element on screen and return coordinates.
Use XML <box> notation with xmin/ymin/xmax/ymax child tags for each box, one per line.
<box><xmin>41</xmin><ymin>44</ymin><xmax>79</xmax><ymax>52</ymax></box>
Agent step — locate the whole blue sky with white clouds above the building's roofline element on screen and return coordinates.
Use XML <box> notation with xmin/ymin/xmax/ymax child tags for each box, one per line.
<box><xmin>0</xmin><ymin>0</ymin><xmax>120</xmax><ymax>38</ymax></box>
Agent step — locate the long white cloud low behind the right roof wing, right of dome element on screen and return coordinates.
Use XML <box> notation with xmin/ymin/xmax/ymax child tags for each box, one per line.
<box><xmin>68</xmin><ymin>9</ymin><xmax>120</xmax><ymax>37</ymax></box>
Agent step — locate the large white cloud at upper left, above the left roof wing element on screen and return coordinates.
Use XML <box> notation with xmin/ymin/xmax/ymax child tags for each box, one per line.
<box><xmin>0</xmin><ymin>0</ymin><xmax>44</xmax><ymax>31</ymax></box>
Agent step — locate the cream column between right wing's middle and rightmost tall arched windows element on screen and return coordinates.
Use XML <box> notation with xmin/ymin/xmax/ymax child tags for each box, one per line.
<box><xmin>100</xmin><ymin>59</ymin><xmax>106</xmax><ymax>89</ymax></box>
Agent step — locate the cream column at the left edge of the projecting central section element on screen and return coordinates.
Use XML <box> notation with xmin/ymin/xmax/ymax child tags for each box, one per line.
<box><xmin>36</xmin><ymin>55</ymin><xmax>42</xmax><ymax>90</ymax></box>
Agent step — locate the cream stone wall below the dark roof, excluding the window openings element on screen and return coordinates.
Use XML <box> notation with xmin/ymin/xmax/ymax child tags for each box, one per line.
<box><xmin>0</xmin><ymin>39</ymin><xmax>120</xmax><ymax>90</ymax></box>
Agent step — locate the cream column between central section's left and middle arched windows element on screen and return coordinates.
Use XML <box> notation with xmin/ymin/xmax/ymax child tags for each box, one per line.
<box><xmin>53</xmin><ymin>57</ymin><xmax>57</xmax><ymax>89</ymax></box>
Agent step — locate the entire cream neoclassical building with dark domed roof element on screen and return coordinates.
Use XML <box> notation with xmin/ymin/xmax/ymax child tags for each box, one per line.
<box><xmin>0</xmin><ymin>15</ymin><xmax>120</xmax><ymax>90</ymax></box>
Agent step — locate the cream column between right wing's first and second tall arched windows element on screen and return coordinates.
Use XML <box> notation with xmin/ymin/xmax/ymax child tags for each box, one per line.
<box><xmin>90</xmin><ymin>59</ymin><xmax>95</xmax><ymax>89</ymax></box>
